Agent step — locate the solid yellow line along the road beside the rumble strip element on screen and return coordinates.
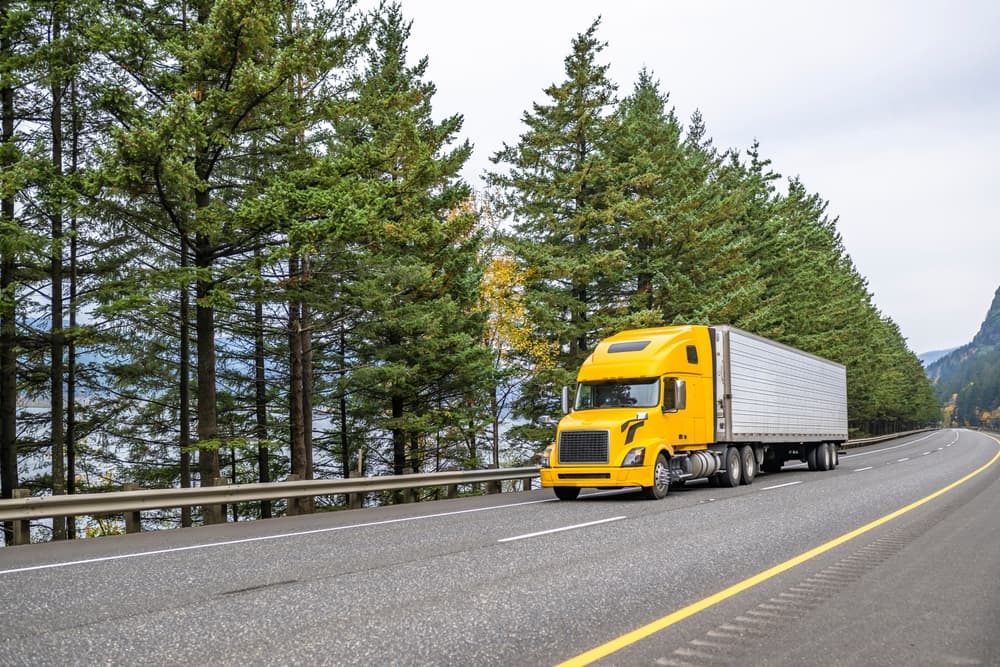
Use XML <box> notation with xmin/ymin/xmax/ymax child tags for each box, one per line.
<box><xmin>556</xmin><ymin>435</ymin><xmax>1000</xmax><ymax>667</ymax></box>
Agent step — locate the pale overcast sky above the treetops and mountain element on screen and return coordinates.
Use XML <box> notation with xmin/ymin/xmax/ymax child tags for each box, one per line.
<box><xmin>376</xmin><ymin>0</ymin><xmax>1000</xmax><ymax>353</ymax></box>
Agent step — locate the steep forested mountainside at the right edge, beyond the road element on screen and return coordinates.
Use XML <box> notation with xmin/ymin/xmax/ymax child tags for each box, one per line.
<box><xmin>927</xmin><ymin>288</ymin><xmax>1000</xmax><ymax>429</ymax></box>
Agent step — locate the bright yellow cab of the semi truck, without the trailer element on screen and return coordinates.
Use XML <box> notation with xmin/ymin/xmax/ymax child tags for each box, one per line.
<box><xmin>541</xmin><ymin>326</ymin><xmax>715</xmax><ymax>499</ymax></box>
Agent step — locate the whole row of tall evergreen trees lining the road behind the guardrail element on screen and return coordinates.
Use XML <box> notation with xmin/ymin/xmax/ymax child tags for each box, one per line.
<box><xmin>0</xmin><ymin>0</ymin><xmax>939</xmax><ymax>539</ymax></box>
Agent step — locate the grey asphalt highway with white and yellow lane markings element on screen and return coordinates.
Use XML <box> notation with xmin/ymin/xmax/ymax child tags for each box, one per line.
<box><xmin>0</xmin><ymin>430</ymin><xmax>1000</xmax><ymax>665</ymax></box>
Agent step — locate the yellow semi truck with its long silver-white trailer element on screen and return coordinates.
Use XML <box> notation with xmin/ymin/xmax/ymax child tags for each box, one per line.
<box><xmin>541</xmin><ymin>325</ymin><xmax>847</xmax><ymax>500</ymax></box>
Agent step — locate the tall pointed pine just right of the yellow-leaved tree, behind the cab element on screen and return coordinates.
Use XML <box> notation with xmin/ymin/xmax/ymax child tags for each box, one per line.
<box><xmin>489</xmin><ymin>20</ymin><xmax>626</xmax><ymax>430</ymax></box>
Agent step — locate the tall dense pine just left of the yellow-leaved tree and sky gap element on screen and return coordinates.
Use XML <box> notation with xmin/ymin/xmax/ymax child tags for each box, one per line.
<box><xmin>316</xmin><ymin>5</ymin><xmax>489</xmax><ymax>486</ymax></box>
